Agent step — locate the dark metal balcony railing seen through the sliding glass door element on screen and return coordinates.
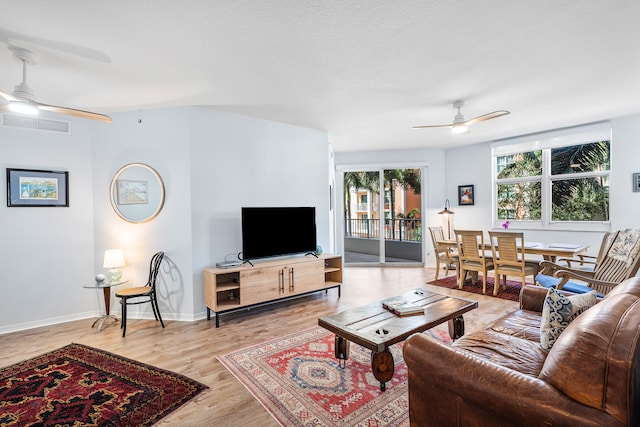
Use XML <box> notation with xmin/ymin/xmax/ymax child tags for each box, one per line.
<box><xmin>344</xmin><ymin>218</ymin><xmax>422</xmax><ymax>242</ymax></box>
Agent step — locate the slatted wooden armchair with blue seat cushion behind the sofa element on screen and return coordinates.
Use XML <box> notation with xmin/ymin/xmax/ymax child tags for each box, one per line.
<box><xmin>536</xmin><ymin>228</ymin><xmax>640</xmax><ymax>296</ymax></box>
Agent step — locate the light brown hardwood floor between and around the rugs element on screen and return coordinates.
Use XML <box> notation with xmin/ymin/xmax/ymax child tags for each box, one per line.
<box><xmin>0</xmin><ymin>267</ymin><xmax>517</xmax><ymax>426</ymax></box>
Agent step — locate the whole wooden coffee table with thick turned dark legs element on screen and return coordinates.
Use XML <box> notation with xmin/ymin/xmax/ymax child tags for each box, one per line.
<box><xmin>318</xmin><ymin>288</ymin><xmax>478</xmax><ymax>391</ymax></box>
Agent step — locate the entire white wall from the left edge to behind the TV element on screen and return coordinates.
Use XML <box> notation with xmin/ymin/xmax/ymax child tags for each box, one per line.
<box><xmin>0</xmin><ymin>108</ymin><xmax>329</xmax><ymax>333</ymax></box>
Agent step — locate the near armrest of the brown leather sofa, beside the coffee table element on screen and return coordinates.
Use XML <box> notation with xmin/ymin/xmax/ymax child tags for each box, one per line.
<box><xmin>403</xmin><ymin>334</ymin><xmax>615</xmax><ymax>427</ymax></box>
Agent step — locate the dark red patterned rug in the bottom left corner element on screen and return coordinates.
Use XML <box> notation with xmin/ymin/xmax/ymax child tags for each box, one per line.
<box><xmin>0</xmin><ymin>344</ymin><xmax>208</xmax><ymax>426</ymax></box>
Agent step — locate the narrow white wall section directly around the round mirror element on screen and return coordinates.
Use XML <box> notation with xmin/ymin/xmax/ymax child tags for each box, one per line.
<box><xmin>93</xmin><ymin>108</ymin><xmax>194</xmax><ymax>320</ymax></box>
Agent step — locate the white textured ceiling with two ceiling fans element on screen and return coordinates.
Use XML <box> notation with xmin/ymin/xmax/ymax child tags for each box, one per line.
<box><xmin>0</xmin><ymin>0</ymin><xmax>640</xmax><ymax>151</ymax></box>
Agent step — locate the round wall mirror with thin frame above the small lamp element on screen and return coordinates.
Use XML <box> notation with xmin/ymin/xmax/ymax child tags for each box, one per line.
<box><xmin>109</xmin><ymin>163</ymin><xmax>164</xmax><ymax>223</ymax></box>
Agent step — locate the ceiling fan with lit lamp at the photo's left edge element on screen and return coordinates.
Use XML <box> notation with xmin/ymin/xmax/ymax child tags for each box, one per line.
<box><xmin>0</xmin><ymin>45</ymin><xmax>111</xmax><ymax>122</ymax></box>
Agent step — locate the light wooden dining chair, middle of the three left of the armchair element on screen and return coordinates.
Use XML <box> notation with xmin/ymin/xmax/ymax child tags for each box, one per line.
<box><xmin>453</xmin><ymin>230</ymin><xmax>494</xmax><ymax>294</ymax></box>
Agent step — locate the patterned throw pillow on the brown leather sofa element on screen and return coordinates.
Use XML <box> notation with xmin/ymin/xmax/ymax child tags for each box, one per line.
<box><xmin>540</xmin><ymin>288</ymin><xmax>597</xmax><ymax>350</ymax></box>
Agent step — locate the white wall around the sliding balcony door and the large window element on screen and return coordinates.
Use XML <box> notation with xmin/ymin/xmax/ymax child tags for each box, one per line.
<box><xmin>336</xmin><ymin>115</ymin><xmax>640</xmax><ymax>265</ymax></box>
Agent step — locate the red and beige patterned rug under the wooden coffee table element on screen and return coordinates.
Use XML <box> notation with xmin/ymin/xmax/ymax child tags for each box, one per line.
<box><xmin>218</xmin><ymin>325</ymin><xmax>451</xmax><ymax>427</ymax></box>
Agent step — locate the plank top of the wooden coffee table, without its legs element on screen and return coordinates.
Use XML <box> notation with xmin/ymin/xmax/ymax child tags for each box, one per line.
<box><xmin>318</xmin><ymin>288</ymin><xmax>478</xmax><ymax>351</ymax></box>
